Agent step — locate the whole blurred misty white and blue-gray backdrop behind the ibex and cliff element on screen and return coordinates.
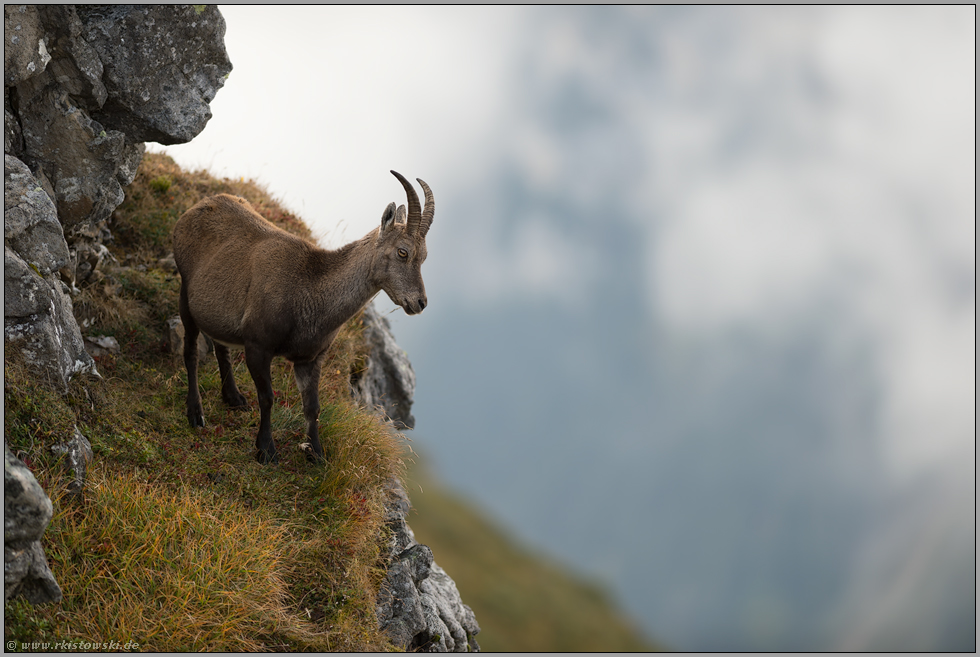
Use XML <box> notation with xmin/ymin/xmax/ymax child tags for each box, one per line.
<box><xmin>157</xmin><ymin>6</ymin><xmax>976</xmax><ymax>651</ymax></box>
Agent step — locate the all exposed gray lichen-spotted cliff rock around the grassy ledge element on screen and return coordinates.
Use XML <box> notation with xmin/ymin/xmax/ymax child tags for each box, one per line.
<box><xmin>4</xmin><ymin>5</ymin><xmax>479</xmax><ymax>651</ymax></box>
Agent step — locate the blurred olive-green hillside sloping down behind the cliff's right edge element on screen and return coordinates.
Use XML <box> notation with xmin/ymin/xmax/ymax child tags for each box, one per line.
<box><xmin>406</xmin><ymin>460</ymin><xmax>663</xmax><ymax>652</ymax></box>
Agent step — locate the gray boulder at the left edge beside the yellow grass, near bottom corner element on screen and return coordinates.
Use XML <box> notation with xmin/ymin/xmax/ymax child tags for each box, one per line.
<box><xmin>3</xmin><ymin>443</ymin><xmax>61</xmax><ymax>604</ymax></box>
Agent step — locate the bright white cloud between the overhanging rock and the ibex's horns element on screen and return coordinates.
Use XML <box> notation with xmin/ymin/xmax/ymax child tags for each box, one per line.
<box><xmin>154</xmin><ymin>5</ymin><xmax>521</xmax><ymax>246</ymax></box>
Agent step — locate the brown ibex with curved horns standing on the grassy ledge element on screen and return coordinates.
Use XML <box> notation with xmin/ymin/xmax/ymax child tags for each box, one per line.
<box><xmin>174</xmin><ymin>171</ymin><xmax>435</xmax><ymax>463</ymax></box>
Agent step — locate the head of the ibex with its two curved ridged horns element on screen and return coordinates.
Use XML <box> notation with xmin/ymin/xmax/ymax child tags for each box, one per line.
<box><xmin>372</xmin><ymin>171</ymin><xmax>436</xmax><ymax>315</ymax></box>
